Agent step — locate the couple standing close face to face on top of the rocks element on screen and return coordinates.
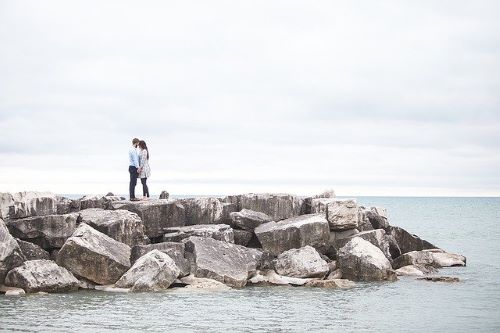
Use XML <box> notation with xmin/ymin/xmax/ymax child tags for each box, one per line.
<box><xmin>128</xmin><ymin>138</ymin><xmax>151</xmax><ymax>201</ymax></box>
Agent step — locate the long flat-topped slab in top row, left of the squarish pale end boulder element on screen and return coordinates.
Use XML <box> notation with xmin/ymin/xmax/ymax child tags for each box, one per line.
<box><xmin>224</xmin><ymin>193</ymin><xmax>303</xmax><ymax>221</ymax></box>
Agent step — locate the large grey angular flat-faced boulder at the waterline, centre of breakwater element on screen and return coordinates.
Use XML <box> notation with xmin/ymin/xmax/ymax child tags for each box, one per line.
<box><xmin>185</xmin><ymin>236</ymin><xmax>262</xmax><ymax>288</ymax></box>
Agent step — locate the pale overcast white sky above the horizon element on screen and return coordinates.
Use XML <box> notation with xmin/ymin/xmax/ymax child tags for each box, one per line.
<box><xmin>0</xmin><ymin>0</ymin><xmax>500</xmax><ymax>196</ymax></box>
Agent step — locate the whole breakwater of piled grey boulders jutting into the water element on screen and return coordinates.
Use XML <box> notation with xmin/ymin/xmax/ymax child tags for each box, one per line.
<box><xmin>0</xmin><ymin>191</ymin><xmax>466</xmax><ymax>294</ymax></box>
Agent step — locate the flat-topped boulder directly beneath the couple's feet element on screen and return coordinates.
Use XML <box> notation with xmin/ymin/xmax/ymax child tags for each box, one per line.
<box><xmin>111</xmin><ymin>199</ymin><xmax>186</xmax><ymax>238</ymax></box>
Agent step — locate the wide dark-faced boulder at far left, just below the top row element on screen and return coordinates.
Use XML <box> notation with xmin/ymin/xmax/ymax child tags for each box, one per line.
<box><xmin>7</xmin><ymin>213</ymin><xmax>78</xmax><ymax>250</ymax></box>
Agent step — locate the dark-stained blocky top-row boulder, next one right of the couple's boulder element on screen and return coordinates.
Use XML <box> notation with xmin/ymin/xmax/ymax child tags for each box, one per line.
<box><xmin>180</xmin><ymin>198</ymin><xmax>230</xmax><ymax>225</ymax></box>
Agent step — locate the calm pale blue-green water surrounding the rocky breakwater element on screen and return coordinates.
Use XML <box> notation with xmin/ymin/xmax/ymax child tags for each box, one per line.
<box><xmin>0</xmin><ymin>197</ymin><xmax>500</xmax><ymax>332</ymax></box>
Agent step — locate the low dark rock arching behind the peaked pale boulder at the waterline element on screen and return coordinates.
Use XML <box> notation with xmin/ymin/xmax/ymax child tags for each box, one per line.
<box><xmin>130</xmin><ymin>242</ymin><xmax>191</xmax><ymax>276</ymax></box>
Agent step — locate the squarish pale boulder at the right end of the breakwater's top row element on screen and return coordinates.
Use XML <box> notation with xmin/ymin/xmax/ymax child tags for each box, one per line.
<box><xmin>326</xmin><ymin>199</ymin><xmax>359</xmax><ymax>231</ymax></box>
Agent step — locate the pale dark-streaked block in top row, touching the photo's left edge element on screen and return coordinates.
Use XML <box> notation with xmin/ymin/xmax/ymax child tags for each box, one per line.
<box><xmin>0</xmin><ymin>192</ymin><xmax>57</xmax><ymax>219</ymax></box>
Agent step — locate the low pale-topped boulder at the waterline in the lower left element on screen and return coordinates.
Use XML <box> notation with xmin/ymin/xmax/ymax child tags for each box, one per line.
<box><xmin>5</xmin><ymin>259</ymin><xmax>78</xmax><ymax>293</ymax></box>
